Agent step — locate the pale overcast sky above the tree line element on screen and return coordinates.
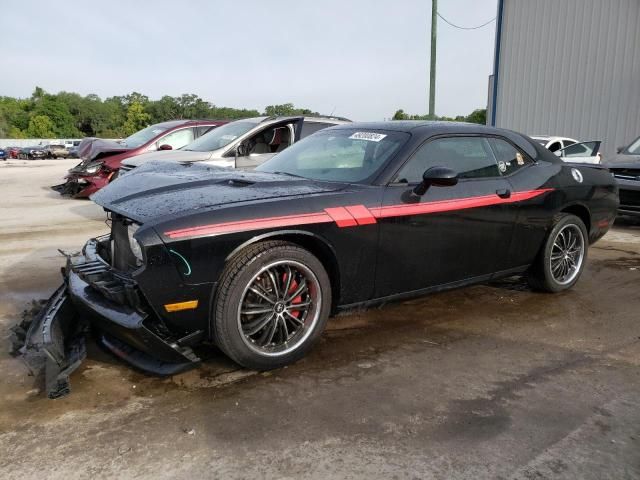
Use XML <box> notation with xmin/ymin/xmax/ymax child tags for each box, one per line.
<box><xmin>0</xmin><ymin>0</ymin><xmax>497</xmax><ymax>121</ymax></box>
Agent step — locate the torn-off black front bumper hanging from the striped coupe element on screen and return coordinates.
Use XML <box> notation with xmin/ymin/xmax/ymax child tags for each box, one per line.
<box><xmin>13</xmin><ymin>236</ymin><xmax>200</xmax><ymax>398</ymax></box>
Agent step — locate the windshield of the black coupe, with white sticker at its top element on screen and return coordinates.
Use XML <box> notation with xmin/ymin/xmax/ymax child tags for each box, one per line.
<box><xmin>256</xmin><ymin>129</ymin><xmax>409</xmax><ymax>183</ymax></box>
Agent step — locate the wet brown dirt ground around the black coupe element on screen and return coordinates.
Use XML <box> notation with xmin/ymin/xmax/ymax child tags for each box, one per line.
<box><xmin>0</xmin><ymin>161</ymin><xmax>640</xmax><ymax>480</ymax></box>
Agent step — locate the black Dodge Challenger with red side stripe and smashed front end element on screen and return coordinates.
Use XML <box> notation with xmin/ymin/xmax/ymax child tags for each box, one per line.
<box><xmin>13</xmin><ymin>122</ymin><xmax>618</xmax><ymax>397</ymax></box>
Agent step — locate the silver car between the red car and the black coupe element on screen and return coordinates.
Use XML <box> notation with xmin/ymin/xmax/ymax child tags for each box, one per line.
<box><xmin>121</xmin><ymin>116</ymin><xmax>351</xmax><ymax>172</ymax></box>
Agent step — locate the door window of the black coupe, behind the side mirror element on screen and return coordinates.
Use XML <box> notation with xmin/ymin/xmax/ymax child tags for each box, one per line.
<box><xmin>394</xmin><ymin>137</ymin><xmax>500</xmax><ymax>183</ymax></box>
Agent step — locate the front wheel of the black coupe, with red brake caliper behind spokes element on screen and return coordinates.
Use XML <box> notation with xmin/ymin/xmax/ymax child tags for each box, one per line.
<box><xmin>212</xmin><ymin>241</ymin><xmax>331</xmax><ymax>370</ymax></box>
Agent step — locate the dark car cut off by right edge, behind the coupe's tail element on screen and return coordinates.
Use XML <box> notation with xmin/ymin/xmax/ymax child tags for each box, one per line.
<box><xmin>605</xmin><ymin>137</ymin><xmax>640</xmax><ymax>216</ymax></box>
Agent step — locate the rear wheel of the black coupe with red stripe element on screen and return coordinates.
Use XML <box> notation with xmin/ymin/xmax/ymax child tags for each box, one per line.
<box><xmin>527</xmin><ymin>213</ymin><xmax>589</xmax><ymax>293</ymax></box>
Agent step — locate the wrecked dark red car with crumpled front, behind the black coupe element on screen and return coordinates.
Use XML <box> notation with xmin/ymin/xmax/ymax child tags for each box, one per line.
<box><xmin>51</xmin><ymin>120</ymin><xmax>227</xmax><ymax>198</ymax></box>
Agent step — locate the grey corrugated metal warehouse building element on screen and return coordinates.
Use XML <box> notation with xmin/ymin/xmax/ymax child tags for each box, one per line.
<box><xmin>487</xmin><ymin>0</ymin><xmax>640</xmax><ymax>158</ymax></box>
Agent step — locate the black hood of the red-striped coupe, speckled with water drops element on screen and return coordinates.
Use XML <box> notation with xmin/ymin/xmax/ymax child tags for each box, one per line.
<box><xmin>91</xmin><ymin>162</ymin><xmax>344</xmax><ymax>223</ymax></box>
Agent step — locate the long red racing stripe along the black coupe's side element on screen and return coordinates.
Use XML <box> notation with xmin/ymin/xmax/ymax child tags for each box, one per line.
<box><xmin>165</xmin><ymin>188</ymin><xmax>553</xmax><ymax>238</ymax></box>
